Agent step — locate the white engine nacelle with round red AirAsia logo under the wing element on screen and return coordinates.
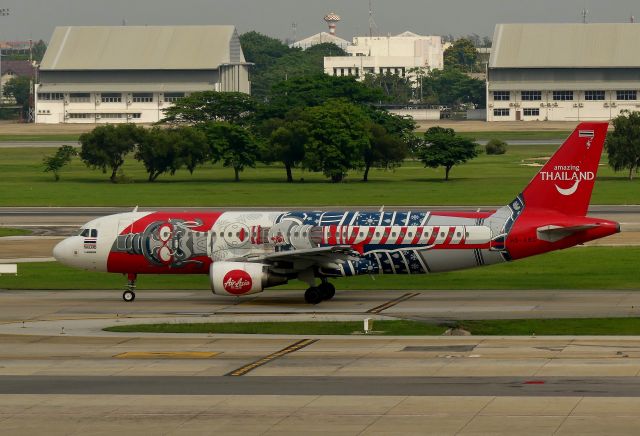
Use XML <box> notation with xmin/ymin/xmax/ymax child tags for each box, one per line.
<box><xmin>209</xmin><ymin>262</ymin><xmax>287</xmax><ymax>296</ymax></box>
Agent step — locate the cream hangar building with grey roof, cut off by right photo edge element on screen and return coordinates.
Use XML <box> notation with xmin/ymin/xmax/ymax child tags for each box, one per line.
<box><xmin>487</xmin><ymin>23</ymin><xmax>640</xmax><ymax>121</ymax></box>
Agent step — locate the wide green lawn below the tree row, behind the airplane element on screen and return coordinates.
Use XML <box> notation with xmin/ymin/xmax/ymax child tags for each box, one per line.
<box><xmin>0</xmin><ymin>145</ymin><xmax>640</xmax><ymax>207</ymax></box>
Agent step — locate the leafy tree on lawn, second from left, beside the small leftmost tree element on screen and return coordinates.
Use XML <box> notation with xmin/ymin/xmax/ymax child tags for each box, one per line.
<box><xmin>80</xmin><ymin>124</ymin><xmax>144</xmax><ymax>183</ymax></box>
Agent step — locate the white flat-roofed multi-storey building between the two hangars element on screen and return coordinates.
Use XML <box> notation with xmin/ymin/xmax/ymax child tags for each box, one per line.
<box><xmin>324</xmin><ymin>32</ymin><xmax>444</xmax><ymax>84</ymax></box>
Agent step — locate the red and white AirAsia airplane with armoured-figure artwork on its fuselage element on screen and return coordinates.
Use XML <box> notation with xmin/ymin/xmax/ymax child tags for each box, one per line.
<box><xmin>53</xmin><ymin>122</ymin><xmax>620</xmax><ymax>304</ymax></box>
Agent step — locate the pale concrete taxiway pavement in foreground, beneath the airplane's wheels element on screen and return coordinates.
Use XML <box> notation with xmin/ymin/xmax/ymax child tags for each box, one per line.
<box><xmin>0</xmin><ymin>291</ymin><xmax>640</xmax><ymax>435</ymax></box>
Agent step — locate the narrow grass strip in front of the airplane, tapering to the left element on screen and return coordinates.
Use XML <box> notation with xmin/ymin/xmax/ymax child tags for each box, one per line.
<box><xmin>104</xmin><ymin>318</ymin><xmax>640</xmax><ymax>336</ymax></box>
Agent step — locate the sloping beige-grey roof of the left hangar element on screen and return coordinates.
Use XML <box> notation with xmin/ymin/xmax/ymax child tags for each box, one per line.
<box><xmin>40</xmin><ymin>26</ymin><xmax>245</xmax><ymax>71</ymax></box>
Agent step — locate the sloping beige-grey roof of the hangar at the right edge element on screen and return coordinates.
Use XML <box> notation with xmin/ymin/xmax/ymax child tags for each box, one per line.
<box><xmin>489</xmin><ymin>23</ymin><xmax>640</xmax><ymax>68</ymax></box>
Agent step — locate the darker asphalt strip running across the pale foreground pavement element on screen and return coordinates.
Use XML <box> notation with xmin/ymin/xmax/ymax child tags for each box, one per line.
<box><xmin>0</xmin><ymin>376</ymin><xmax>640</xmax><ymax>397</ymax></box>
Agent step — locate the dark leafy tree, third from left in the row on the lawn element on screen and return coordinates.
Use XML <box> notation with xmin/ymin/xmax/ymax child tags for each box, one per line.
<box><xmin>135</xmin><ymin>127</ymin><xmax>181</xmax><ymax>182</ymax></box>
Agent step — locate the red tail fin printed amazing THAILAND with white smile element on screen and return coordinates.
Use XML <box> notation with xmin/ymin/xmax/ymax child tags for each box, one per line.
<box><xmin>522</xmin><ymin>122</ymin><xmax>609</xmax><ymax>216</ymax></box>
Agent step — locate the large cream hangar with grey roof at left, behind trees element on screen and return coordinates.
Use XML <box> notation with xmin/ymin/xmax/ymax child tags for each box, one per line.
<box><xmin>35</xmin><ymin>26</ymin><xmax>250</xmax><ymax>123</ymax></box>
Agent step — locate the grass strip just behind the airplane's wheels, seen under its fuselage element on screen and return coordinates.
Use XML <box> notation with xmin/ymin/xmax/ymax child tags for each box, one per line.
<box><xmin>0</xmin><ymin>247</ymin><xmax>640</xmax><ymax>292</ymax></box>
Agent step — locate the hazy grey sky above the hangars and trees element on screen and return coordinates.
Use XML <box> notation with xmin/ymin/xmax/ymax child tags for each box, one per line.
<box><xmin>0</xmin><ymin>0</ymin><xmax>640</xmax><ymax>41</ymax></box>
